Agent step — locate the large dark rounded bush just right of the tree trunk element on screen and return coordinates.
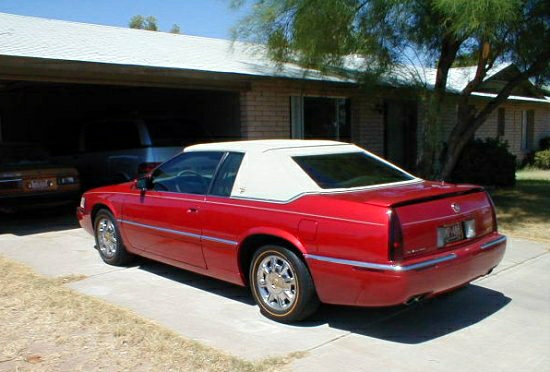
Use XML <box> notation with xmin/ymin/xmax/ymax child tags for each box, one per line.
<box><xmin>451</xmin><ymin>138</ymin><xmax>516</xmax><ymax>186</ymax></box>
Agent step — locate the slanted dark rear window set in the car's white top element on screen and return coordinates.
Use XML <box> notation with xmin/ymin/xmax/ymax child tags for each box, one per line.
<box><xmin>292</xmin><ymin>152</ymin><xmax>413</xmax><ymax>189</ymax></box>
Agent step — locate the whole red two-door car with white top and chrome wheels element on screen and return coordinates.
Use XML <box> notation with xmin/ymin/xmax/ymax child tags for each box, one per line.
<box><xmin>77</xmin><ymin>140</ymin><xmax>506</xmax><ymax>322</ymax></box>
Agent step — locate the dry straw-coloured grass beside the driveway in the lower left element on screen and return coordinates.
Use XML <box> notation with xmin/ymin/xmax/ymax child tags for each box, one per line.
<box><xmin>0</xmin><ymin>256</ymin><xmax>301</xmax><ymax>371</ymax></box>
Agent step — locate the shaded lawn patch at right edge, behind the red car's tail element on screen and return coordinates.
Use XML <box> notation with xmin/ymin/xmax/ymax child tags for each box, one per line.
<box><xmin>491</xmin><ymin>169</ymin><xmax>550</xmax><ymax>241</ymax></box>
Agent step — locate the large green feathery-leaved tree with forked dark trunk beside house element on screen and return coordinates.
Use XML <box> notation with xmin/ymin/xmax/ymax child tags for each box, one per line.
<box><xmin>233</xmin><ymin>0</ymin><xmax>550</xmax><ymax>179</ymax></box>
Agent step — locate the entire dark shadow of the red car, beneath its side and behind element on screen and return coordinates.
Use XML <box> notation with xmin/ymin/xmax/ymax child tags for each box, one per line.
<box><xmin>137</xmin><ymin>259</ymin><xmax>512</xmax><ymax>344</ymax></box>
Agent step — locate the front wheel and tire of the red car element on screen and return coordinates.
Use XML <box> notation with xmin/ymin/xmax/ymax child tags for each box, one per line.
<box><xmin>94</xmin><ymin>209</ymin><xmax>134</xmax><ymax>266</ymax></box>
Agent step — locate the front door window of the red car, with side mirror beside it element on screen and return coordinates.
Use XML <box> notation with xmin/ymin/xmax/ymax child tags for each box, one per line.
<box><xmin>152</xmin><ymin>152</ymin><xmax>223</xmax><ymax>194</ymax></box>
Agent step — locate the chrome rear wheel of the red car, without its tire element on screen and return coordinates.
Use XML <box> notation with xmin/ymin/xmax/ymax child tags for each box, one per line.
<box><xmin>256</xmin><ymin>255</ymin><xmax>297</xmax><ymax>311</ymax></box>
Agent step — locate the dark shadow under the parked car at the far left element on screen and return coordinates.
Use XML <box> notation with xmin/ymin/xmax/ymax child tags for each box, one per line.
<box><xmin>0</xmin><ymin>204</ymin><xmax>80</xmax><ymax>236</ymax></box>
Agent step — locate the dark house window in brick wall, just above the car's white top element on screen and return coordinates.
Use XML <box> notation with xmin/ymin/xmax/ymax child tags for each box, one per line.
<box><xmin>290</xmin><ymin>97</ymin><xmax>351</xmax><ymax>142</ymax></box>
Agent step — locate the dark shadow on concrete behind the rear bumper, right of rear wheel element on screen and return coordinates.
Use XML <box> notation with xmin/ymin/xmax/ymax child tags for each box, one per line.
<box><xmin>302</xmin><ymin>284</ymin><xmax>512</xmax><ymax>344</ymax></box>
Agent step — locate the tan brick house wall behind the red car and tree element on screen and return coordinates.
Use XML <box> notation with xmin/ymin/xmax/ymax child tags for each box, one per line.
<box><xmin>240</xmin><ymin>79</ymin><xmax>550</xmax><ymax>163</ymax></box>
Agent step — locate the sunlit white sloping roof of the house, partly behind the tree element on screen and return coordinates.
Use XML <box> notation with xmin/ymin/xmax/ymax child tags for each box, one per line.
<box><xmin>0</xmin><ymin>13</ymin><xmax>550</xmax><ymax>103</ymax></box>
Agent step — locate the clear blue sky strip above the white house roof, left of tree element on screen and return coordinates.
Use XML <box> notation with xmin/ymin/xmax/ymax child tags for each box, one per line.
<box><xmin>0</xmin><ymin>0</ymin><xmax>251</xmax><ymax>39</ymax></box>
